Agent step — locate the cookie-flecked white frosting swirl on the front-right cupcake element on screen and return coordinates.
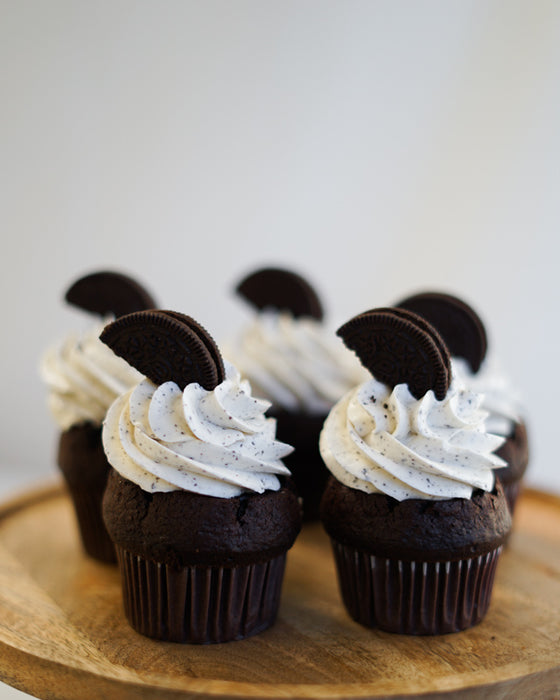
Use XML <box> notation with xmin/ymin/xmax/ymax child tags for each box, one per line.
<box><xmin>320</xmin><ymin>379</ymin><xmax>505</xmax><ymax>501</ymax></box>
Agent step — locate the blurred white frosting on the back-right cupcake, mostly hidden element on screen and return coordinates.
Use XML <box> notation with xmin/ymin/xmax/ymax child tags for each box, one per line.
<box><xmin>452</xmin><ymin>357</ymin><xmax>522</xmax><ymax>437</ymax></box>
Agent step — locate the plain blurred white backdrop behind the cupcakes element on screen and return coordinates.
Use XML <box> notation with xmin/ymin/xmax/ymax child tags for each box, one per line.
<box><xmin>0</xmin><ymin>0</ymin><xmax>560</xmax><ymax>500</ymax></box>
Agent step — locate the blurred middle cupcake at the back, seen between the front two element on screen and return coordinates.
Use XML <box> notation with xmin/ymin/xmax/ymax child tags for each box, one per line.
<box><xmin>224</xmin><ymin>268</ymin><xmax>364</xmax><ymax>520</ymax></box>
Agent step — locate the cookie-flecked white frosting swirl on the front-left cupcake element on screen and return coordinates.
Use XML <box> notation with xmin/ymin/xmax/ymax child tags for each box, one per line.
<box><xmin>103</xmin><ymin>362</ymin><xmax>293</xmax><ymax>498</ymax></box>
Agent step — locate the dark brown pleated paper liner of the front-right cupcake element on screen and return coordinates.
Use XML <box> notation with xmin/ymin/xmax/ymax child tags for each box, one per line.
<box><xmin>331</xmin><ymin>540</ymin><xmax>502</xmax><ymax>634</ymax></box>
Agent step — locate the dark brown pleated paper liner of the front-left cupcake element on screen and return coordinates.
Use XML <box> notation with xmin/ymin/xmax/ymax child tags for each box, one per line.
<box><xmin>117</xmin><ymin>546</ymin><xmax>286</xmax><ymax>644</ymax></box>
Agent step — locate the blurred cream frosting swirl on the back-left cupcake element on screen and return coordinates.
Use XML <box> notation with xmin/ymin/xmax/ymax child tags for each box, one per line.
<box><xmin>40</xmin><ymin>320</ymin><xmax>142</xmax><ymax>430</ymax></box>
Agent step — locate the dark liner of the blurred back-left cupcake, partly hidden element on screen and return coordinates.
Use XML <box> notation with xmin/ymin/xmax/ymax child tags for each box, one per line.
<box><xmin>67</xmin><ymin>483</ymin><xmax>117</xmax><ymax>564</ymax></box>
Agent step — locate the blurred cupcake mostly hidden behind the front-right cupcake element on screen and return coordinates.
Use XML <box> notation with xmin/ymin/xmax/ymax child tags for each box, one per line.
<box><xmin>398</xmin><ymin>292</ymin><xmax>529</xmax><ymax>513</ymax></box>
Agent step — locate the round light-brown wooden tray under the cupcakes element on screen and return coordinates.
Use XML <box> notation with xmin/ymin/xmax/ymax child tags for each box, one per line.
<box><xmin>0</xmin><ymin>485</ymin><xmax>560</xmax><ymax>700</ymax></box>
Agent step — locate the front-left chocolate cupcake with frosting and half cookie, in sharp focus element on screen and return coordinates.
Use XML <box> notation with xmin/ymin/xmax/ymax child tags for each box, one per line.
<box><xmin>101</xmin><ymin>310</ymin><xmax>301</xmax><ymax>644</ymax></box>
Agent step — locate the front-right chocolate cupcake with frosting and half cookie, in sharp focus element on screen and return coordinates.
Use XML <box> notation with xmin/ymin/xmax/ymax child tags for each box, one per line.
<box><xmin>320</xmin><ymin>309</ymin><xmax>511</xmax><ymax>635</ymax></box>
